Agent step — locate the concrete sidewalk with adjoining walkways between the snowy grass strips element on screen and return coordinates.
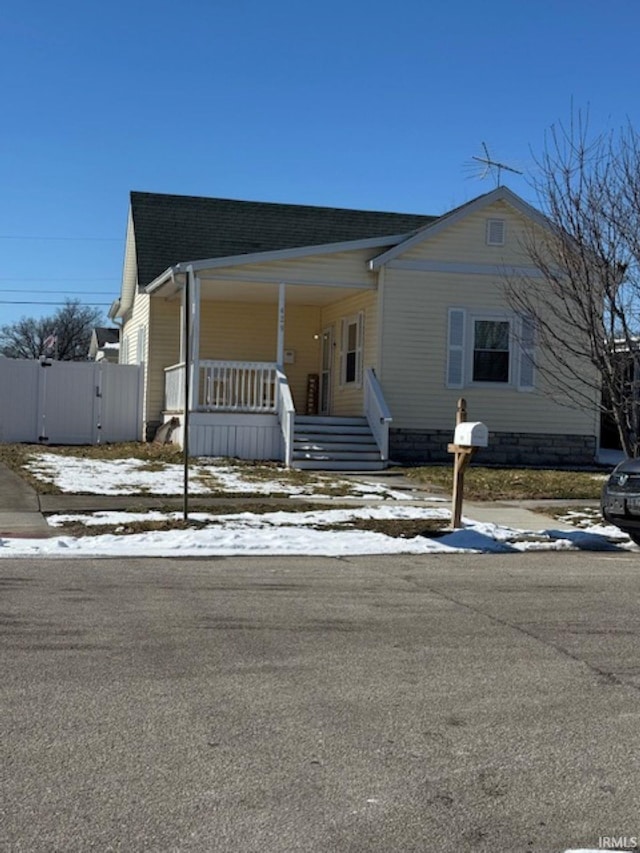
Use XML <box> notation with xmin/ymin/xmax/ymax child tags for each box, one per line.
<box><xmin>0</xmin><ymin>463</ymin><xmax>584</xmax><ymax>538</ymax></box>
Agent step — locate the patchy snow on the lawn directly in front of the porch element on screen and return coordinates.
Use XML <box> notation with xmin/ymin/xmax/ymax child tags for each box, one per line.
<box><xmin>27</xmin><ymin>453</ymin><xmax>422</xmax><ymax>500</ymax></box>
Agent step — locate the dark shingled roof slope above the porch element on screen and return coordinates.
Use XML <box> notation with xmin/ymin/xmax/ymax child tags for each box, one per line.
<box><xmin>131</xmin><ymin>192</ymin><xmax>438</xmax><ymax>285</ymax></box>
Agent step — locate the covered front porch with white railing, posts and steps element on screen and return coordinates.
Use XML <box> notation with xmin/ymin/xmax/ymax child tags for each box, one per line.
<box><xmin>151</xmin><ymin>268</ymin><xmax>391</xmax><ymax>469</ymax></box>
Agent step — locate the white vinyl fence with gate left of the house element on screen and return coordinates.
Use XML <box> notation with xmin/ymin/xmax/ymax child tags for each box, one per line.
<box><xmin>0</xmin><ymin>358</ymin><xmax>142</xmax><ymax>444</ymax></box>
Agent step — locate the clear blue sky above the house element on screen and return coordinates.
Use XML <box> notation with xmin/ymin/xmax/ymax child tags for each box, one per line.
<box><xmin>0</xmin><ymin>0</ymin><xmax>640</xmax><ymax>325</ymax></box>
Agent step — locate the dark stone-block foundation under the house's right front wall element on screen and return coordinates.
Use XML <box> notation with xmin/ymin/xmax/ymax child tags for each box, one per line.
<box><xmin>389</xmin><ymin>427</ymin><xmax>597</xmax><ymax>467</ymax></box>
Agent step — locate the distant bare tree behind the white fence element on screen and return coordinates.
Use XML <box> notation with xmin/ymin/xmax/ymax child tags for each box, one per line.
<box><xmin>0</xmin><ymin>299</ymin><xmax>102</xmax><ymax>361</ymax></box>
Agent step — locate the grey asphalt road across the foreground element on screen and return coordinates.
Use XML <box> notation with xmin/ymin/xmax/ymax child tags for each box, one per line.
<box><xmin>0</xmin><ymin>553</ymin><xmax>640</xmax><ymax>853</ymax></box>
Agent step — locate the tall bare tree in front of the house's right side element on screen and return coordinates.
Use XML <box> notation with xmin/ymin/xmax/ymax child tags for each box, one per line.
<box><xmin>506</xmin><ymin>114</ymin><xmax>640</xmax><ymax>456</ymax></box>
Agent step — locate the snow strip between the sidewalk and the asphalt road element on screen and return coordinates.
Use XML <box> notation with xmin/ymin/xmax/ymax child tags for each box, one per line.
<box><xmin>0</xmin><ymin>504</ymin><xmax>632</xmax><ymax>558</ymax></box>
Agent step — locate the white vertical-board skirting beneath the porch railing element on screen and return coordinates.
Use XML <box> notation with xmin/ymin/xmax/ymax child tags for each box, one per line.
<box><xmin>165</xmin><ymin>412</ymin><xmax>284</xmax><ymax>461</ymax></box>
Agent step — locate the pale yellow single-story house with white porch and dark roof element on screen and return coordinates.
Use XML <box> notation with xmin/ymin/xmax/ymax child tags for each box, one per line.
<box><xmin>110</xmin><ymin>187</ymin><xmax>599</xmax><ymax>469</ymax></box>
